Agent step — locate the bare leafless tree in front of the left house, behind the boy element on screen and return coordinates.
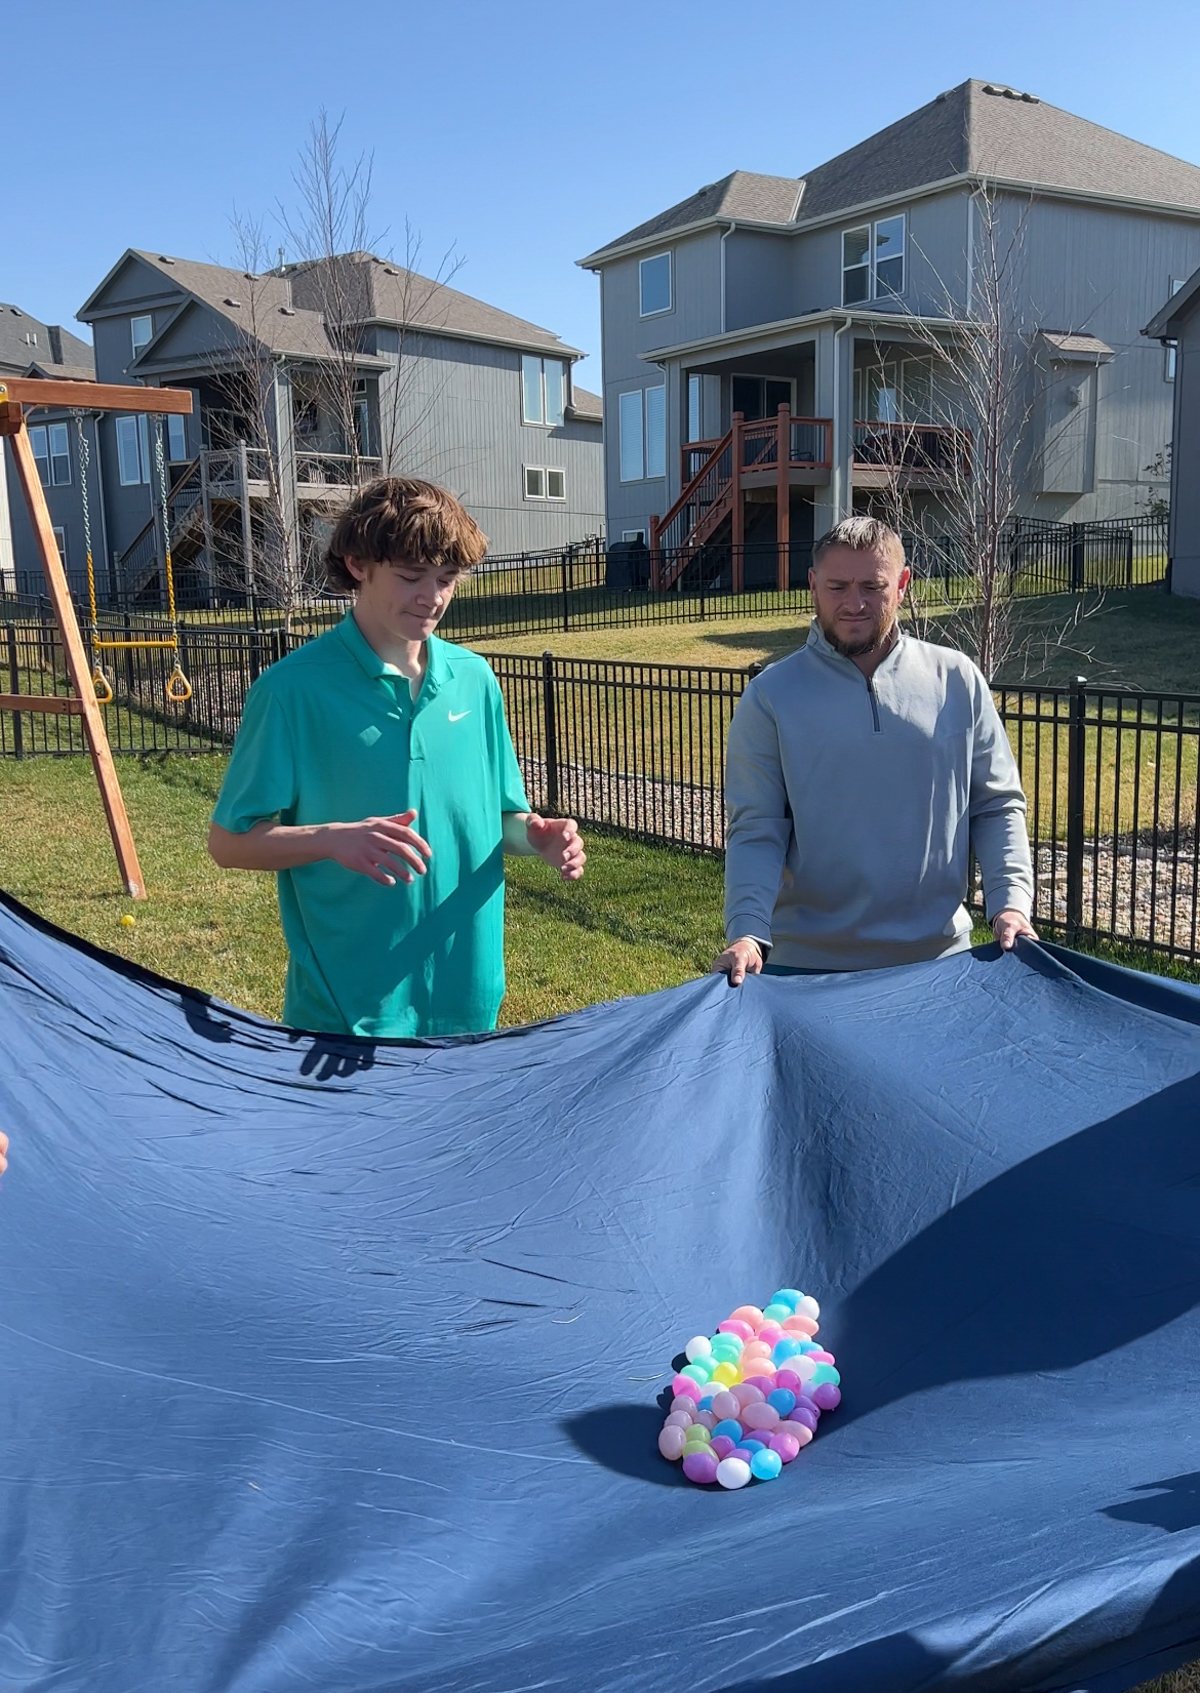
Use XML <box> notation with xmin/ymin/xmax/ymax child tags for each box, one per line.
<box><xmin>218</xmin><ymin>110</ymin><xmax>460</xmax><ymax>628</ymax></box>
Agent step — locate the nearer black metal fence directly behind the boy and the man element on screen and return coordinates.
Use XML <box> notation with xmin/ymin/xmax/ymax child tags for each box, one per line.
<box><xmin>0</xmin><ymin>623</ymin><xmax>1200</xmax><ymax>962</ymax></box>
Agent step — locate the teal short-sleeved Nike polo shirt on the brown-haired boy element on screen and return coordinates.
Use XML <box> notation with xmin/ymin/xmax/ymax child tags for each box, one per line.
<box><xmin>213</xmin><ymin>613</ymin><xmax>530</xmax><ymax>1038</ymax></box>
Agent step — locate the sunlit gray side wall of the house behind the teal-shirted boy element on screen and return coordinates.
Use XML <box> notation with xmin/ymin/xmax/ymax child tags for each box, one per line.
<box><xmin>374</xmin><ymin>332</ymin><xmax>604</xmax><ymax>554</ymax></box>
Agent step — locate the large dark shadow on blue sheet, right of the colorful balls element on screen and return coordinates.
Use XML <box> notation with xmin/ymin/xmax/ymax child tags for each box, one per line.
<box><xmin>834</xmin><ymin>1073</ymin><xmax>1200</xmax><ymax>1429</ymax></box>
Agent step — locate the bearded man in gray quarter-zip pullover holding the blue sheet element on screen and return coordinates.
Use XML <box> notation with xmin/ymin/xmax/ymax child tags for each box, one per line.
<box><xmin>714</xmin><ymin>516</ymin><xmax>1034</xmax><ymax>985</ymax></box>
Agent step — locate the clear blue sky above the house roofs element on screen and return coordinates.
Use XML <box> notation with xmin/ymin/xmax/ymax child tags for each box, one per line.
<box><xmin>9</xmin><ymin>0</ymin><xmax>1200</xmax><ymax>388</ymax></box>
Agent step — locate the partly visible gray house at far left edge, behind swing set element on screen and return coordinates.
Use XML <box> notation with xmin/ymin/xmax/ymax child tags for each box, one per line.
<box><xmin>0</xmin><ymin>303</ymin><xmax>103</xmax><ymax>594</ymax></box>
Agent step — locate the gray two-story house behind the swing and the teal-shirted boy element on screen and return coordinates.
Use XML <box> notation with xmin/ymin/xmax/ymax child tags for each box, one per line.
<box><xmin>67</xmin><ymin>249</ymin><xmax>603</xmax><ymax>601</ymax></box>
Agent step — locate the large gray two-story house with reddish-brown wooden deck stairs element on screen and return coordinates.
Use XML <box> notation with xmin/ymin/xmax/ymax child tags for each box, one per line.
<box><xmin>579</xmin><ymin>81</ymin><xmax>1200</xmax><ymax>586</ymax></box>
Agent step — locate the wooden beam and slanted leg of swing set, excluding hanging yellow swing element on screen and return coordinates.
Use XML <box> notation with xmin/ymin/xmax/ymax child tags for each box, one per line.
<box><xmin>0</xmin><ymin>378</ymin><xmax>191</xmax><ymax>899</ymax></box>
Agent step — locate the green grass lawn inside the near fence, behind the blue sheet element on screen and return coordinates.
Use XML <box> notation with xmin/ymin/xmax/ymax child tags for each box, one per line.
<box><xmin>0</xmin><ymin>757</ymin><xmax>721</xmax><ymax>1024</ymax></box>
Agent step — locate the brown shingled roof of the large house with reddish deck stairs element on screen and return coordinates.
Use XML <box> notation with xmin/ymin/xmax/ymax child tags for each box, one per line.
<box><xmin>582</xmin><ymin>80</ymin><xmax>1200</xmax><ymax>264</ymax></box>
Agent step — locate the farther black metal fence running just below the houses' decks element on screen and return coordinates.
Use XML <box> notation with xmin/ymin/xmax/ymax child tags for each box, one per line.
<box><xmin>0</xmin><ymin>515</ymin><xmax>1166</xmax><ymax>640</ymax></box>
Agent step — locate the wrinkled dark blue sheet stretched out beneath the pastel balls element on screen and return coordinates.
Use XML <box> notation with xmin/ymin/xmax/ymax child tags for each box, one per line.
<box><xmin>0</xmin><ymin>902</ymin><xmax>1200</xmax><ymax>1693</ymax></box>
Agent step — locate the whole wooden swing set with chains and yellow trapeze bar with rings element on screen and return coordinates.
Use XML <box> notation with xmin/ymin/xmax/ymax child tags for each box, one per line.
<box><xmin>0</xmin><ymin>376</ymin><xmax>191</xmax><ymax>899</ymax></box>
